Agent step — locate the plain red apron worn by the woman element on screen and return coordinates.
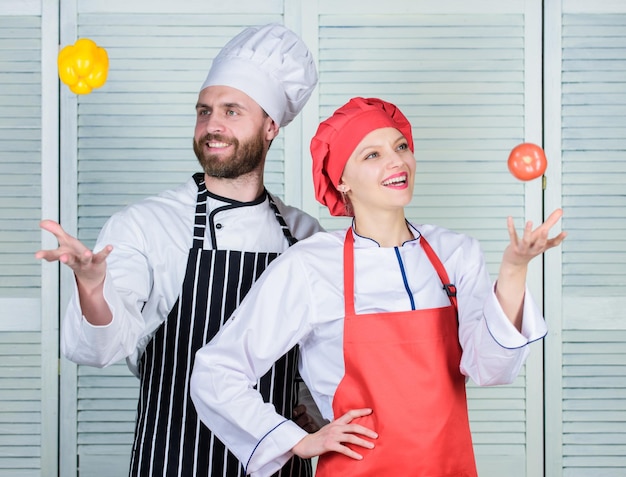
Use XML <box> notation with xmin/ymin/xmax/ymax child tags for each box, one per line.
<box><xmin>315</xmin><ymin>228</ymin><xmax>478</xmax><ymax>477</ymax></box>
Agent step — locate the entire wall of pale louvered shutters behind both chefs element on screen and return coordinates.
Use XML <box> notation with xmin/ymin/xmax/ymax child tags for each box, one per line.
<box><xmin>0</xmin><ymin>0</ymin><xmax>626</xmax><ymax>477</ymax></box>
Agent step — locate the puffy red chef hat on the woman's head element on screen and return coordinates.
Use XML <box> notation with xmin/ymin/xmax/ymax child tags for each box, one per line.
<box><xmin>311</xmin><ymin>98</ymin><xmax>414</xmax><ymax>216</ymax></box>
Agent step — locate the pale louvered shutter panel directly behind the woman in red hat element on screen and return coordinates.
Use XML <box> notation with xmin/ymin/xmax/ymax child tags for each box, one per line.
<box><xmin>303</xmin><ymin>1</ymin><xmax>543</xmax><ymax>477</ymax></box>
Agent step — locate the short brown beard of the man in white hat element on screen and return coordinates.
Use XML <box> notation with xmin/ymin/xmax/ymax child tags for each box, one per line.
<box><xmin>193</xmin><ymin>134</ymin><xmax>265</xmax><ymax>179</ymax></box>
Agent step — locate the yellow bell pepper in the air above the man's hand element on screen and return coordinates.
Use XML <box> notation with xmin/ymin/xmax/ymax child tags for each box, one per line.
<box><xmin>57</xmin><ymin>38</ymin><xmax>109</xmax><ymax>94</ymax></box>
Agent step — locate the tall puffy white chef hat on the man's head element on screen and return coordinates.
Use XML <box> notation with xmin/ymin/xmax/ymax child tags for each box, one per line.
<box><xmin>201</xmin><ymin>23</ymin><xmax>317</xmax><ymax>126</ymax></box>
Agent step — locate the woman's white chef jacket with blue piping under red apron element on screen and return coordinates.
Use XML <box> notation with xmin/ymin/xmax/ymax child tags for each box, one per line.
<box><xmin>191</xmin><ymin>225</ymin><xmax>547</xmax><ymax>476</ymax></box>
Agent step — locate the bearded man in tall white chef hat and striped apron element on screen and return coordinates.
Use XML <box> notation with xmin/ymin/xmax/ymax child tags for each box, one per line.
<box><xmin>36</xmin><ymin>24</ymin><xmax>320</xmax><ymax>477</ymax></box>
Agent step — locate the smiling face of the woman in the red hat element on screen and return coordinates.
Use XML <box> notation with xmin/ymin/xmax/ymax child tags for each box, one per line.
<box><xmin>340</xmin><ymin>127</ymin><xmax>415</xmax><ymax>215</ymax></box>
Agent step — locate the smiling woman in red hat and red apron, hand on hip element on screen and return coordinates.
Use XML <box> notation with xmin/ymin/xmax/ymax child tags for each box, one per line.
<box><xmin>191</xmin><ymin>98</ymin><xmax>565</xmax><ymax>477</ymax></box>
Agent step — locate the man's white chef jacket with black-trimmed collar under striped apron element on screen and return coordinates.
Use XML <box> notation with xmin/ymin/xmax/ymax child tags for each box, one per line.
<box><xmin>61</xmin><ymin>178</ymin><xmax>321</xmax><ymax>374</ymax></box>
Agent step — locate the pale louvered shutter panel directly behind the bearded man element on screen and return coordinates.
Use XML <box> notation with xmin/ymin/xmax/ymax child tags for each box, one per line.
<box><xmin>62</xmin><ymin>0</ymin><xmax>289</xmax><ymax>477</ymax></box>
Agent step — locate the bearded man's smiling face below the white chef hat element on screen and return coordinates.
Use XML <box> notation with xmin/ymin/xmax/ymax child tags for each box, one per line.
<box><xmin>193</xmin><ymin>86</ymin><xmax>278</xmax><ymax>179</ymax></box>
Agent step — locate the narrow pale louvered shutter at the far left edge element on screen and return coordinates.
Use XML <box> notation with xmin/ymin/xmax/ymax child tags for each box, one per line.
<box><xmin>0</xmin><ymin>2</ymin><xmax>58</xmax><ymax>477</ymax></box>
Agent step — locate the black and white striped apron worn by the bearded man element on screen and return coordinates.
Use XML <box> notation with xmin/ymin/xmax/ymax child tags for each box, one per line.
<box><xmin>130</xmin><ymin>173</ymin><xmax>313</xmax><ymax>477</ymax></box>
